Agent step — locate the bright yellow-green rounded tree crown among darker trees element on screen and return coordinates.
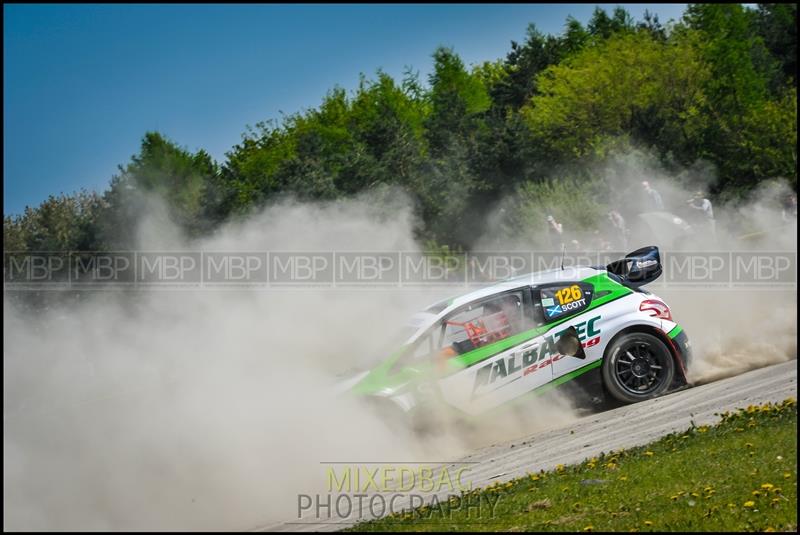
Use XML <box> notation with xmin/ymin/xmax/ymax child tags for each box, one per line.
<box><xmin>522</xmin><ymin>32</ymin><xmax>708</xmax><ymax>160</ymax></box>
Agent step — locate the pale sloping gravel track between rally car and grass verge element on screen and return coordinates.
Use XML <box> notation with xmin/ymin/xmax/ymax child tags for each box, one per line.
<box><xmin>257</xmin><ymin>360</ymin><xmax>797</xmax><ymax>531</ymax></box>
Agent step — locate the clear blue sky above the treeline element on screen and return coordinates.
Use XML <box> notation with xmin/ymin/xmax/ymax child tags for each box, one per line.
<box><xmin>3</xmin><ymin>4</ymin><xmax>685</xmax><ymax>214</ymax></box>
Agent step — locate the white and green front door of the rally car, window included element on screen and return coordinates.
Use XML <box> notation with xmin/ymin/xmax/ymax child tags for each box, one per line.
<box><xmin>438</xmin><ymin>287</ymin><xmax>552</xmax><ymax>414</ymax></box>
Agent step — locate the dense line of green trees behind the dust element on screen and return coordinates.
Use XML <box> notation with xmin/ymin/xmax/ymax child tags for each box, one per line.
<box><xmin>3</xmin><ymin>4</ymin><xmax>797</xmax><ymax>251</ymax></box>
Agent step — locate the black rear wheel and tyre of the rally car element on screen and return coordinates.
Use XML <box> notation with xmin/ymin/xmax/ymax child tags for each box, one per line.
<box><xmin>602</xmin><ymin>332</ymin><xmax>675</xmax><ymax>403</ymax></box>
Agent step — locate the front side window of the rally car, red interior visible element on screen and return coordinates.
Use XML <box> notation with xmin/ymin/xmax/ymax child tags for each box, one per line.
<box><xmin>440</xmin><ymin>290</ymin><xmax>532</xmax><ymax>356</ymax></box>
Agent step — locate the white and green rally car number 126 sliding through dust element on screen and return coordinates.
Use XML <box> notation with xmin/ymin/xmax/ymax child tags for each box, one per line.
<box><xmin>340</xmin><ymin>246</ymin><xmax>690</xmax><ymax>428</ymax></box>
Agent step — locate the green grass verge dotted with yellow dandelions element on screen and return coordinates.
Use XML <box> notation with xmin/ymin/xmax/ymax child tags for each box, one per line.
<box><xmin>348</xmin><ymin>399</ymin><xmax>797</xmax><ymax>531</ymax></box>
